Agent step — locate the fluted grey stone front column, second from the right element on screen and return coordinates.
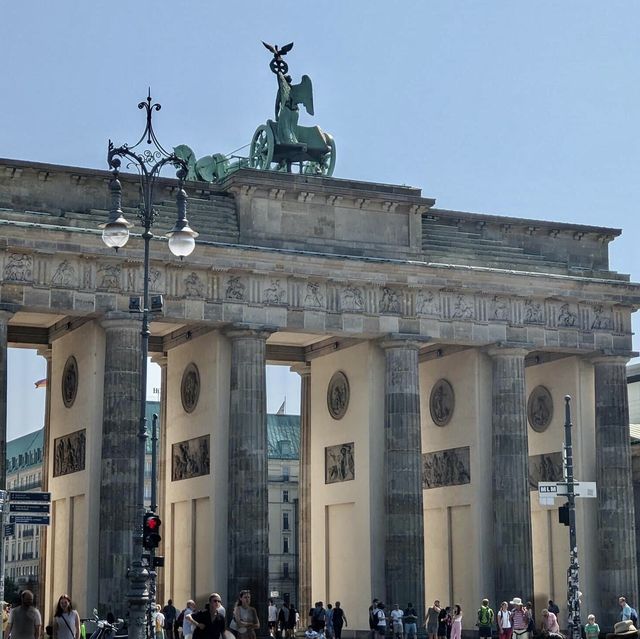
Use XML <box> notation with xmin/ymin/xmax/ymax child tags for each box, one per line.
<box><xmin>486</xmin><ymin>348</ymin><xmax>533</xmax><ymax>602</ymax></box>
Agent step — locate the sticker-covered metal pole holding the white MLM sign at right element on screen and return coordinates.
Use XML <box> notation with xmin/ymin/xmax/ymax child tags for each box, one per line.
<box><xmin>564</xmin><ymin>395</ymin><xmax>582</xmax><ymax>639</ymax></box>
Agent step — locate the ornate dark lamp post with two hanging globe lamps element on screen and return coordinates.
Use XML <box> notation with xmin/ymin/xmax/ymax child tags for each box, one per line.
<box><xmin>100</xmin><ymin>91</ymin><xmax>198</xmax><ymax>639</ymax></box>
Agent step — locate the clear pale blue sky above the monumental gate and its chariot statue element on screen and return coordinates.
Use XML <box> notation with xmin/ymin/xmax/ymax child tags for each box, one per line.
<box><xmin>0</xmin><ymin>0</ymin><xmax>640</xmax><ymax>438</ymax></box>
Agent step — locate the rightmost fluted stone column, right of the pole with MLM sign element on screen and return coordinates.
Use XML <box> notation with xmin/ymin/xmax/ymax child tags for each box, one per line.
<box><xmin>582</xmin><ymin>357</ymin><xmax>638</xmax><ymax>628</ymax></box>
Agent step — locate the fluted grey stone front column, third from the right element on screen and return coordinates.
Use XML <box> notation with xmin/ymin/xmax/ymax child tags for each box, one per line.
<box><xmin>381</xmin><ymin>338</ymin><xmax>424</xmax><ymax>619</ymax></box>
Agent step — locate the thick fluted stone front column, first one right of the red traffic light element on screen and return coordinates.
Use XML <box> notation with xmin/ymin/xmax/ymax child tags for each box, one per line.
<box><xmin>227</xmin><ymin>327</ymin><xmax>271</xmax><ymax>634</ymax></box>
